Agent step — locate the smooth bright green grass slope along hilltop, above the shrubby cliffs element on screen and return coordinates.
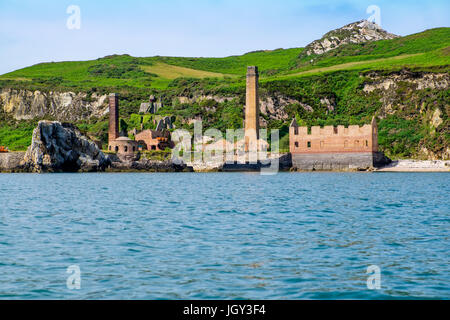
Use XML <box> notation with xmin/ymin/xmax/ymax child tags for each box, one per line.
<box><xmin>0</xmin><ymin>28</ymin><xmax>450</xmax><ymax>90</ymax></box>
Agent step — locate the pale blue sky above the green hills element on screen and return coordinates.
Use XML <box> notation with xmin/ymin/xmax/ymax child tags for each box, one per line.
<box><xmin>0</xmin><ymin>0</ymin><xmax>450</xmax><ymax>74</ymax></box>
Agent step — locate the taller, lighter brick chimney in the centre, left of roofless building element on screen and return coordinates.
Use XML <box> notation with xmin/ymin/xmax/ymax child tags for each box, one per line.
<box><xmin>245</xmin><ymin>66</ymin><xmax>259</xmax><ymax>149</ymax></box>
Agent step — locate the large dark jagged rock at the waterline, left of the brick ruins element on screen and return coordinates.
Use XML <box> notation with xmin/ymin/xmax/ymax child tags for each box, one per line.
<box><xmin>23</xmin><ymin>121</ymin><xmax>110</xmax><ymax>172</ymax></box>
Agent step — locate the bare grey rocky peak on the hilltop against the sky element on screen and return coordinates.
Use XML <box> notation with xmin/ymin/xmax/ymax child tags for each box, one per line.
<box><xmin>304</xmin><ymin>20</ymin><xmax>398</xmax><ymax>56</ymax></box>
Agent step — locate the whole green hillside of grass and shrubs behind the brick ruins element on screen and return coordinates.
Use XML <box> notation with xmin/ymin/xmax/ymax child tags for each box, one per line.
<box><xmin>0</xmin><ymin>28</ymin><xmax>450</xmax><ymax>158</ymax></box>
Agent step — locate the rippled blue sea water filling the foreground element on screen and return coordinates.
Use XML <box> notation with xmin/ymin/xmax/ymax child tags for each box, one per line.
<box><xmin>0</xmin><ymin>173</ymin><xmax>450</xmax><ymax>299</ymax></box>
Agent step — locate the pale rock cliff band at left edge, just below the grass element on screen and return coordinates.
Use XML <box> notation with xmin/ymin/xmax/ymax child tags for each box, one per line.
<box><xmin>0</xmin><ymin>88</ymin><xmax>109</xmax><ymax>122</ymax></box>
